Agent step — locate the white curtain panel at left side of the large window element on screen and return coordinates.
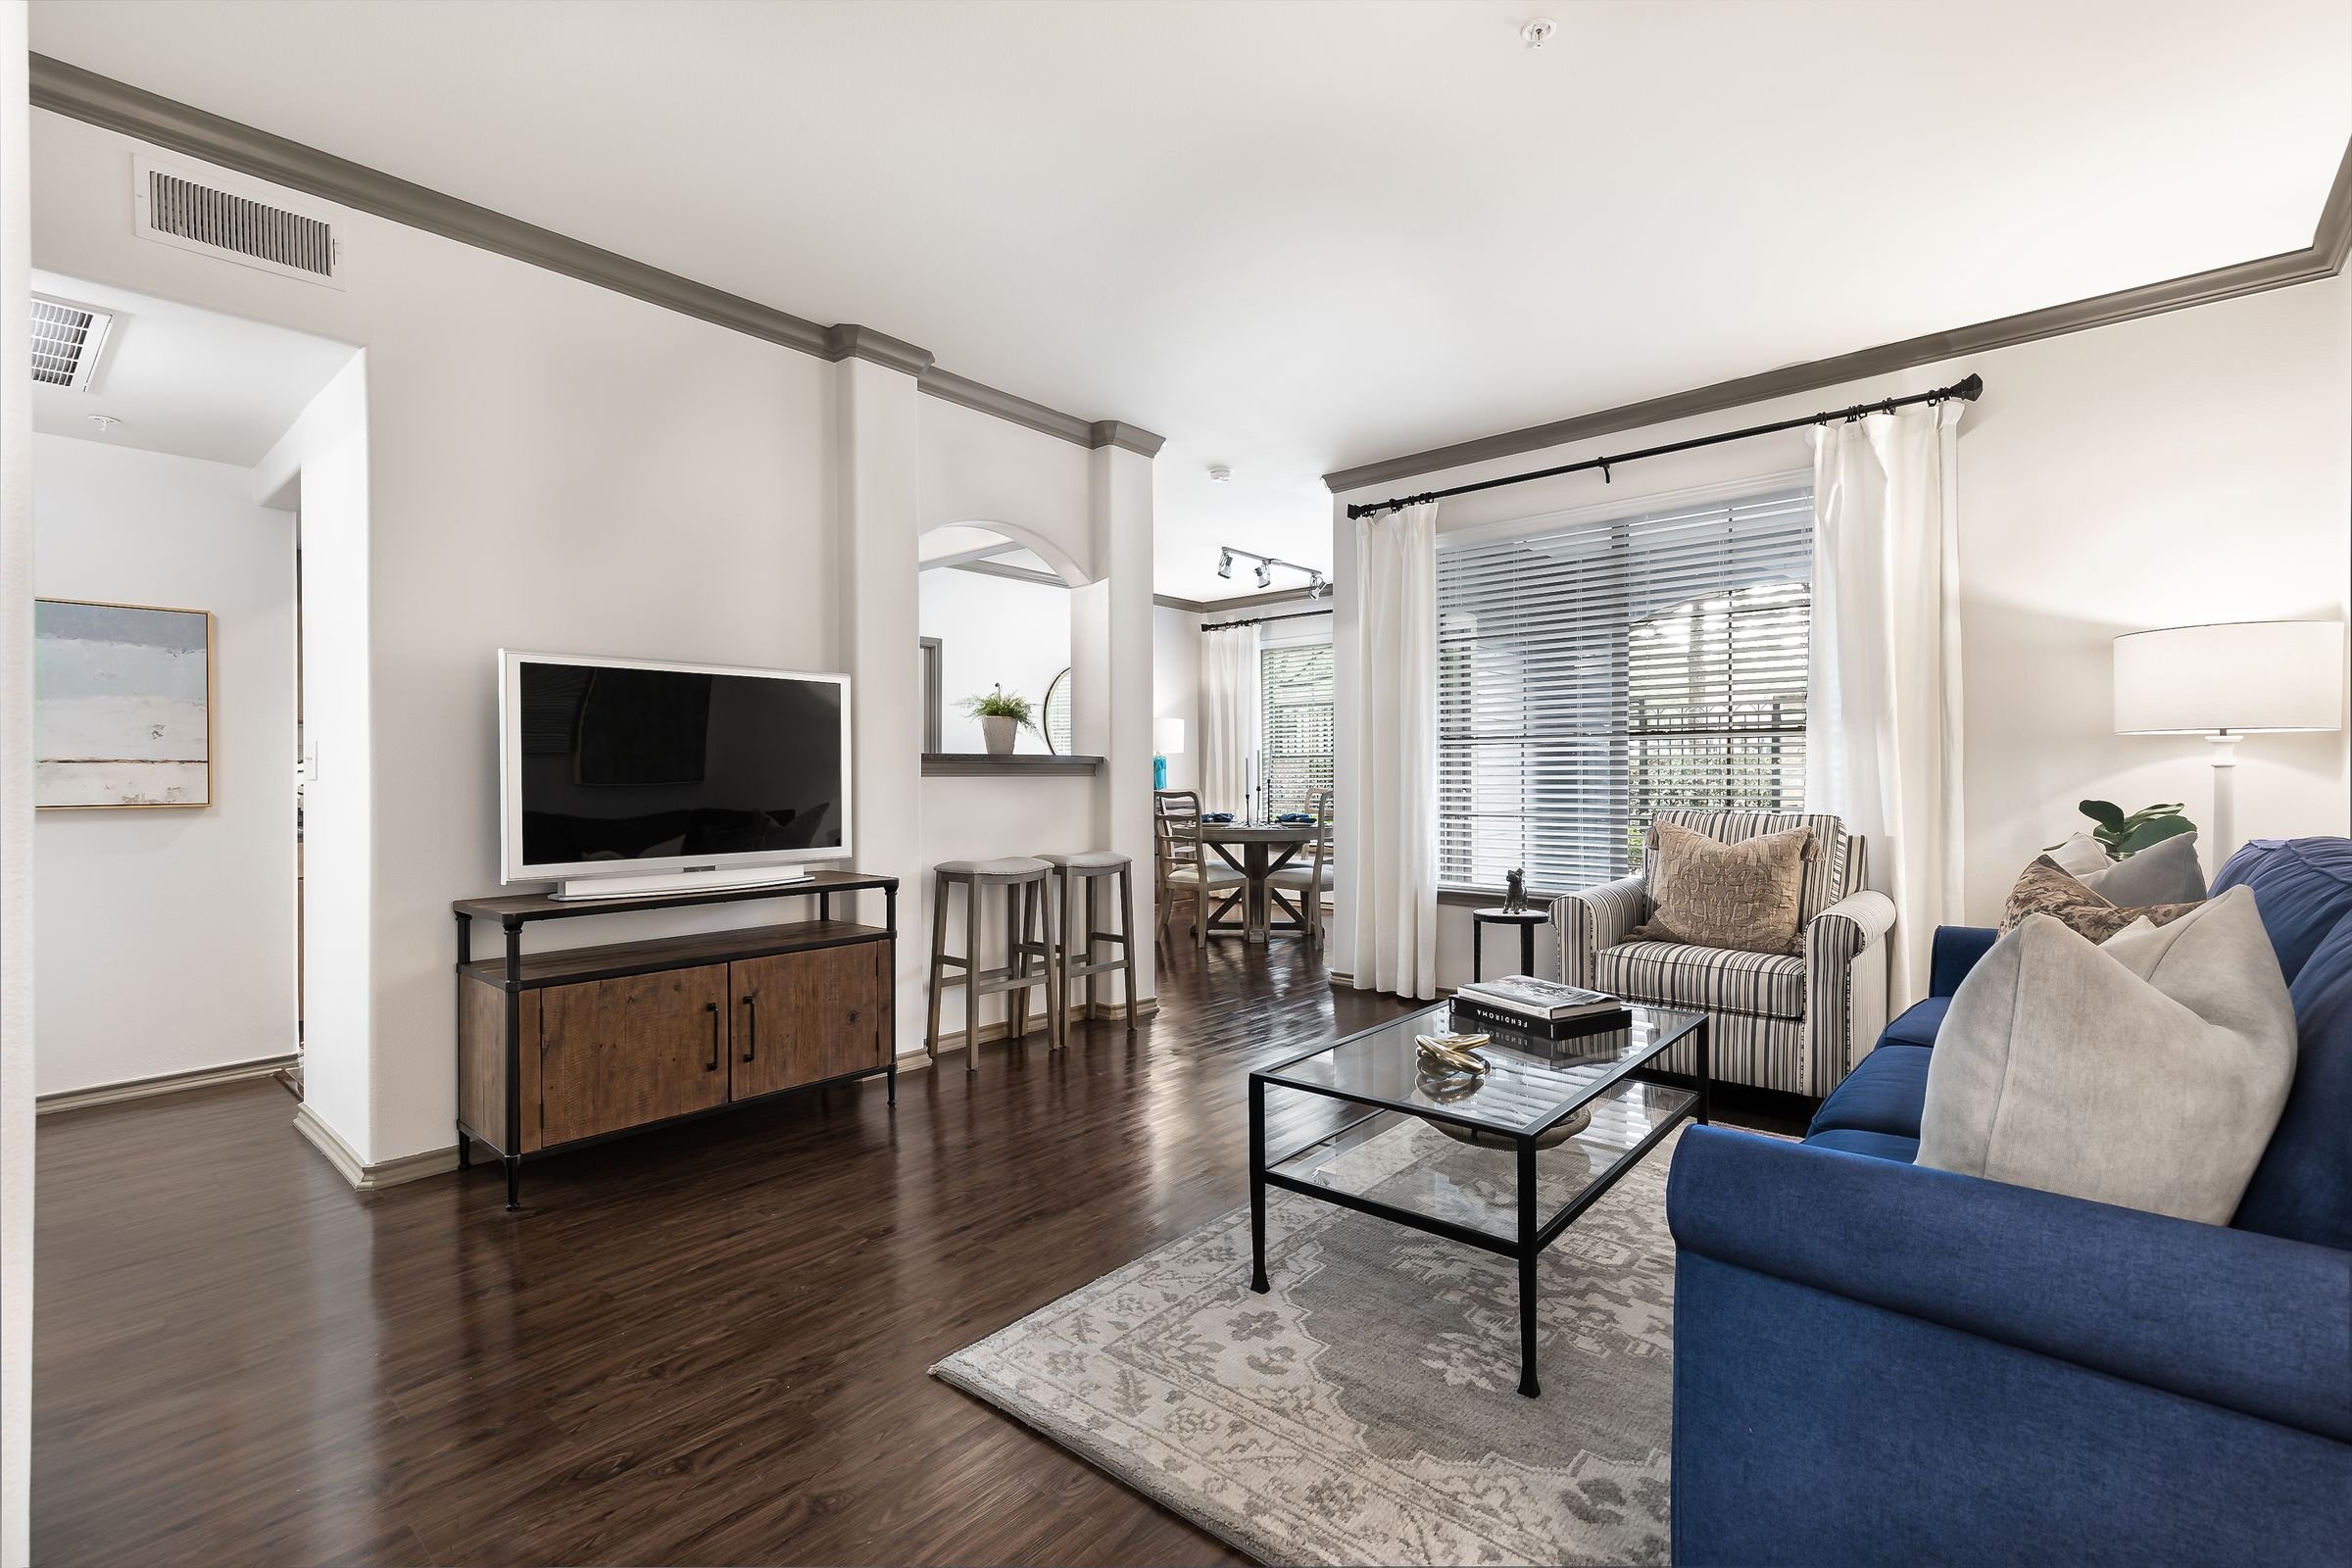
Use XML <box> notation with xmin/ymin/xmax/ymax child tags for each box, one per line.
<box><xmin>1339</xmin><ymin>501</ymin><xmax>1437</xmax><ymax>997</ymax></box>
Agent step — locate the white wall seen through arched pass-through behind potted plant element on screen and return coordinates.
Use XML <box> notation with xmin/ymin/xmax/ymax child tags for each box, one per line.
<box><xmin>917</xmin><ymin>566</ymin><xmax>1077</xmax><ymax>755</ymax></box>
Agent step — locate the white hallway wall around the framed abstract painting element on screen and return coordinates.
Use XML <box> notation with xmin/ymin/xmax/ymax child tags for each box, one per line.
<box><xmin>33</xmin><ymin>435</ymin><xmax>294</xmax><ymax>1093</ymax></box>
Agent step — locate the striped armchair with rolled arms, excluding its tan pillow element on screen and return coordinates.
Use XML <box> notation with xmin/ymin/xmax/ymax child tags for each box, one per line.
<box><xmin>1552</xmin><ymin>811</ymin><xmax>1895</xmax><ymax>1098</ymax></box>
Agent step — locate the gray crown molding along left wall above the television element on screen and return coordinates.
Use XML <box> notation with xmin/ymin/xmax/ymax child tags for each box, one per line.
<box><xmin>28</xmin><ymin>54</ymin><xmax>1162</xmax><ymax>456</ymax></box>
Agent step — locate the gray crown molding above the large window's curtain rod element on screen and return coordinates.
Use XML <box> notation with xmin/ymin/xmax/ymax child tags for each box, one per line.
<box><xmin>1324</xmin><ymin>143</ymin><xmax>2352</xmax><ymax>494</ymax></box>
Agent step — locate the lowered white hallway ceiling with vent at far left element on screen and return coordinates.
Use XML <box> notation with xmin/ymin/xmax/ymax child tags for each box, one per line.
<box><xmin>33</xmin><ymin>272</ymin><xmax>353</xmax><ymax>467</ymax></box>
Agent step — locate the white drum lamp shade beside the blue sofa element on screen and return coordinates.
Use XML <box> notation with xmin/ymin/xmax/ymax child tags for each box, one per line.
<box><xmin>2115</xmin><ymin>620</ymin><xmax>2345</xmax><ymax>736</ymax></box>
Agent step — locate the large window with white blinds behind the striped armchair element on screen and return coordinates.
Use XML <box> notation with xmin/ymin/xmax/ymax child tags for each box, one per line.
<box><xmin>1437</xmin><ymin>487</ymin><xmax>1813</xmax><ymax>891</ymax></box>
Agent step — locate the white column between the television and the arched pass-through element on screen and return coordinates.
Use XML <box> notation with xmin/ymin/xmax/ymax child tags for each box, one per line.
<box><xmin>837</xmin><ymin>358</ymin><xmax>931</xmax><ymax>1054</ymax></box>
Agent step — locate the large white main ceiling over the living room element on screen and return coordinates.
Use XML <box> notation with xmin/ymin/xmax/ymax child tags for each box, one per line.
<box><xmin>33</xmin><ymin>0</ymin><xmax>2352</xmax><ymax>597</ymax></box>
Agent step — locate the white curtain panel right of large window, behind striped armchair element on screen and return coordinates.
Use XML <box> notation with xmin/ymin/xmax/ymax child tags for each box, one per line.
<box><xmin>1804</xmin><ymin>402</ymin><xmax>1969</xmax><ymax>1008</ymax></box>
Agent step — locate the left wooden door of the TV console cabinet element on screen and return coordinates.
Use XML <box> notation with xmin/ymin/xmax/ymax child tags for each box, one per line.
<box><xmin>539</xmin><ymin>964</ymin><xmax>729</xmax><ymax>1145</ymax></box>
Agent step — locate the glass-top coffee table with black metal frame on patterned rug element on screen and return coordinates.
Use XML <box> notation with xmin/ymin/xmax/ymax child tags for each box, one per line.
<box><xmin>1249</xmin><ymin>1004</ymin><xmax>1710</xmax><ymax>1398</ymax></box>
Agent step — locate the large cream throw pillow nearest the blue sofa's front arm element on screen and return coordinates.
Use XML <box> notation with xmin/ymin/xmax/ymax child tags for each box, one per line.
<box><xmin>1919</xmin><ymin>886</ymin><xmax>2295</xmax><ymax>1225</ymax></box>
